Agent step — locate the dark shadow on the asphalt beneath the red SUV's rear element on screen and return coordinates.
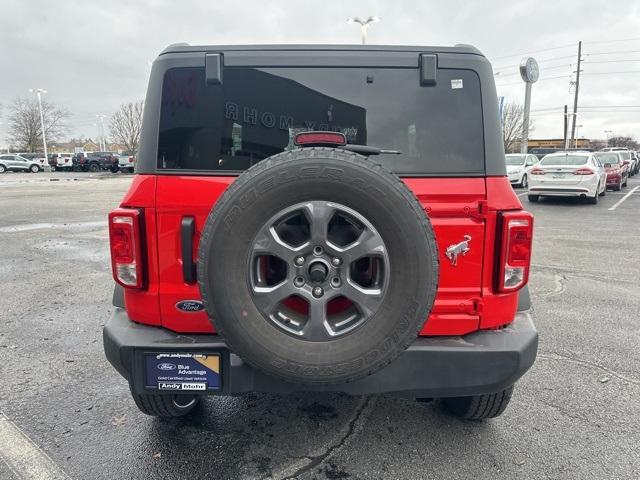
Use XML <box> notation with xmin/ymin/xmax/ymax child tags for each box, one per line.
<box><xmin>121</xmin><ymin>393</ymin><xmax>496</xmax><ymax>478</ymax></box>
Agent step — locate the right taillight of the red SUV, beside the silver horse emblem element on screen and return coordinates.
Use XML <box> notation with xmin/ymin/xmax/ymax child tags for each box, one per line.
<box><xmin>498</xmin><ymin>212</ymin><xmax>533</xmax><ymax>292</ymax></box>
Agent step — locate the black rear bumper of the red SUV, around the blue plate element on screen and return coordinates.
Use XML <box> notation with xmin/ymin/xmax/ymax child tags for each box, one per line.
<box><xmin>103</xmin><ymin>308</ymin><xmax>538</xmax><ymax>398</ymax></box>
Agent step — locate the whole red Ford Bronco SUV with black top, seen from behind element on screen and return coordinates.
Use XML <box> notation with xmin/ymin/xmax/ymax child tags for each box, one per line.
<box><xmin>104</xmin><ymin>44</ymin><xmax>538</xmax><ymax>419</ymax></box>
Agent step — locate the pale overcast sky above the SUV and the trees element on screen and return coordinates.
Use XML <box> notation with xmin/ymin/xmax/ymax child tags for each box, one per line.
<box><xmin>0</xmin><ymin>0</ymin><xmax>640</xmax><ymax>145</ymax></box>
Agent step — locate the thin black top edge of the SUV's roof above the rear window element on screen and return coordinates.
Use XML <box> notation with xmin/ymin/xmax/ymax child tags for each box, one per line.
<box><xmin>160</xmin><ymin>43</ymin><xmax>484</xmax><ymax>56</ymax></box>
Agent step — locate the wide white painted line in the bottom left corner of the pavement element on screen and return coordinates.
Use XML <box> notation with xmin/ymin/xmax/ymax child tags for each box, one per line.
<box><xmin>0</xmin><ymin>412</ymin><xmax>71</xmax><ymax>480</ymax></box>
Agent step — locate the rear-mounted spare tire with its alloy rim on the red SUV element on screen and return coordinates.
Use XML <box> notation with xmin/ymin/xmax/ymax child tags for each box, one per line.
<box><xmin>198</xmin><ymin>148</ymin><xmax>438</xmax><ymax>384</ymax></box>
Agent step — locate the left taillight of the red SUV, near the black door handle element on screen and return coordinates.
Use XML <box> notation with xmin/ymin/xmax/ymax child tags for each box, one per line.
<box><xmin>109</xmin><ymin>208</ymin><xmax>145</xmax><ymax>288</ymax></box>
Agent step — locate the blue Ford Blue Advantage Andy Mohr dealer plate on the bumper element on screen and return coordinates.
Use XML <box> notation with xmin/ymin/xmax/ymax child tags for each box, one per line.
<box><xmin>145</xmin><ymin>352</ymin><xmax>221</xmax><ymax>392</ymax></box>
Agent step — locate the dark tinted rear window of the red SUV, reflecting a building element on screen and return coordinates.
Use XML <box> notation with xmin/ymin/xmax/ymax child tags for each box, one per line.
<box><xmin>158</xmin><ymin>67</ymin><xmax>484</xmax><ymax>174</ymax></box>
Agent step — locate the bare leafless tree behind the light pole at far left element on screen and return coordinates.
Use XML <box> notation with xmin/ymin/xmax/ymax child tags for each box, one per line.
<box><xmin>7</xmin><ymin>97</ymin><xmax>69</xmax><ymax>152</ymax></box>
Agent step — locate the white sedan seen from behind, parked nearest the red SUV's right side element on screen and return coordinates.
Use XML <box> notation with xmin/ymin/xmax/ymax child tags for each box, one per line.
<box><xmin>528</xmin><ymin>151</ymin><xmax>607</xmax><ymax>203</ymax></box>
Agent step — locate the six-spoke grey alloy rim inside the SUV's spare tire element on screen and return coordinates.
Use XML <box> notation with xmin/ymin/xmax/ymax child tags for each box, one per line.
<box><xmin>248</xmin><ymin>201</ymin><xmax>391</xmax><ymax>342</ymax></box>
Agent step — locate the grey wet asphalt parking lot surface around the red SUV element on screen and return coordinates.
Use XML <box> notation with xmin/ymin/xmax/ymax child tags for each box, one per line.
<box><xmin>0</xmin><ymin>173</ymin><xmax>640</xmax><ymax>479</ymax></box>
